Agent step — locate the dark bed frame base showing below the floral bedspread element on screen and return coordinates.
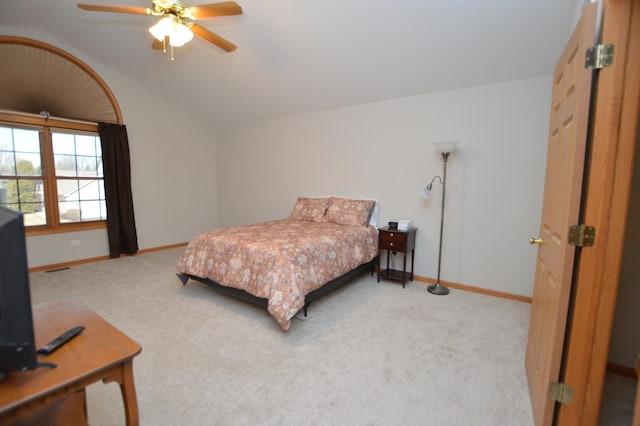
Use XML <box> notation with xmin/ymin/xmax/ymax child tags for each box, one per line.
<box><xmin>179</xmin><ymin>257</ymin><xmax>378</xmax><ymax>317</ymax></box>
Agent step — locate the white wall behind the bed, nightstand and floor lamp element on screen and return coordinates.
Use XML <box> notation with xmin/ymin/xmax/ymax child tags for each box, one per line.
<box><xmin>217</xmin><ymin>77</ymin><xmax>551</xmax><ymax>296</ymax></box>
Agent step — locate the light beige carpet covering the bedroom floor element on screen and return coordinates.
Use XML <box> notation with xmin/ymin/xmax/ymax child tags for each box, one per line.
<box><xmin>31</xmin><ymin>248</ymin><xmax>532</xmax><ymax>426</ymax></box>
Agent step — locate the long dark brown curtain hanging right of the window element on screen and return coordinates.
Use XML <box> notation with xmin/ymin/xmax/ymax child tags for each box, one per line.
<box><xmin>98</xmin><ymin>123</ymin><xmax>138</xmax><ymax>257</ymax></box>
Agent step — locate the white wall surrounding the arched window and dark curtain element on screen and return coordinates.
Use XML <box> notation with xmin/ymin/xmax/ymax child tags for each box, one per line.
<box><xmin>0</xmin><ymin>26</ymin><xmax>218</xmax><ymax>267</ymax></box>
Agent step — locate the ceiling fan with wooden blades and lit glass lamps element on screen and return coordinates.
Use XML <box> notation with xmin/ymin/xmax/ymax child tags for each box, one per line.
<box><xmin>78</xmin><ymin>0</ymin><xmax>242</xmax><ymax>60</ymax></box>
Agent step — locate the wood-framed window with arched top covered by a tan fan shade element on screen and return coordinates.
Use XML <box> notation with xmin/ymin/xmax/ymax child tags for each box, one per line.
<box><xmin>0</xmin><ymin>36</ymin><xmax>122</xmax><ymax>235</ymax></box>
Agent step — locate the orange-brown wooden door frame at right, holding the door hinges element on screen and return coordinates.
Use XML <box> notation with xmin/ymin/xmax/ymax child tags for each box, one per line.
<box><xmin>556</xmin><ymin>0</ymin><xmax>640</xmax><ymax>426</ymax></box>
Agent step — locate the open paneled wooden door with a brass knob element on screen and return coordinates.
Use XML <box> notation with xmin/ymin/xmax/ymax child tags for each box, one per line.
<box><xmin>525</xmin><ymin>3</ymin><xmax>597</xmax><ymax>425</ymax></box>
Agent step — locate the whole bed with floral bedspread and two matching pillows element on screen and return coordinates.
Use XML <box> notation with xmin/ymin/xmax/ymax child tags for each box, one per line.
<box><xmin>176</xmin><ymin>197</ymin><xmax>378</xmax><ymax>331</ymax></box>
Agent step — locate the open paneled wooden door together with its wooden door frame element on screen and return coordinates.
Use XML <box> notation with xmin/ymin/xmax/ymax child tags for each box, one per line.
<box><xmin>525</xmin><ymin>0</ymin><xmax>640</xmax><ymax>426</ymax></box>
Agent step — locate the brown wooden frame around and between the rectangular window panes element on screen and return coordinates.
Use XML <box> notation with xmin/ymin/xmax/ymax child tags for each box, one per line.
<box><xmin>0</xmin><ymin>111</ymin><xmax>107</xmax><ymax>236</ymax></box>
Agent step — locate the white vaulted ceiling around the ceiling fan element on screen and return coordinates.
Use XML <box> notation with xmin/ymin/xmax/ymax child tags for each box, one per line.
<box><xmin>0</xmin><ymin>0</ymin><xmax>574</xmax><ymax>127</ymax></box>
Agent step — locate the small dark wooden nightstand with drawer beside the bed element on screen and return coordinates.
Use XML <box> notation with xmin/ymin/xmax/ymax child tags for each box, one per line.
<box><xmin>378</xmin><ymin>226</ymin><xmax>417</xmax><ymax>288</ymax></box>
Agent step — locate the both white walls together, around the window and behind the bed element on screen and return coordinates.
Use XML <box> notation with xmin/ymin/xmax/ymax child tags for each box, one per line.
<box><xmin>0</xmin><ymin>28</ymin><xmax>551</xmax><ymax>296</ymax></box>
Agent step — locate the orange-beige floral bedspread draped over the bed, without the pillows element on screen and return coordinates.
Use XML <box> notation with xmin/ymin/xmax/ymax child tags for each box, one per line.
<box><xmin>177</xmin><ymin>220</ymin><xmax>378</xmax><ymax>330</ymax></box>
